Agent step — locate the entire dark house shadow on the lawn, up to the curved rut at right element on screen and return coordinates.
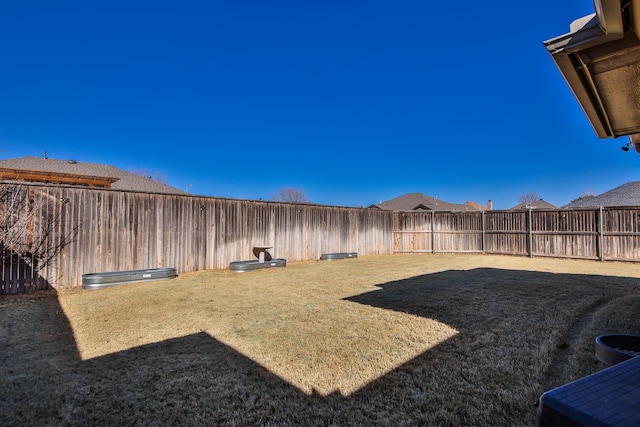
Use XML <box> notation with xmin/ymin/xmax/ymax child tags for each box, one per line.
<box><xmin>0</xmin><ymin>268</ymin><xmax>640</xmax><ymax>426</ymax></box>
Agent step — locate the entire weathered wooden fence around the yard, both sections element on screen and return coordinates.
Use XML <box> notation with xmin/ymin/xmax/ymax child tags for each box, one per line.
<box><xmin>0</xmin><ymin>184</ymin><xmax>640</xmax><ymax>294</ymax></box>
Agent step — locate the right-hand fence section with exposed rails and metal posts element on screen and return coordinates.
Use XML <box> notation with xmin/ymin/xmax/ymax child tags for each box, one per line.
<box><xmin>393</xmin><ymin>207</ymin><xmax>640</xmax><ymax>262</ymax></box>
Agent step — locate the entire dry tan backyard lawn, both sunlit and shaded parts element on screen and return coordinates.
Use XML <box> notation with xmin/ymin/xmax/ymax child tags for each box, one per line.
<box><xmin>0</xmin><ymin>255</ymin><xmax>640</xmax><ymax>426</ymax></box>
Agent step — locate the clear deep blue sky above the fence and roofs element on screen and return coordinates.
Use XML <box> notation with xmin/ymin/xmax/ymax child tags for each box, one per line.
<box><xmin>0</xmin><ymin>0</ymin><xmax>640</xmax><ymax>209</ymax></box>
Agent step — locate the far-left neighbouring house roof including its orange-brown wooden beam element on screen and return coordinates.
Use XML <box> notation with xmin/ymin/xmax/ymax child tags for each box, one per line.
<box><xmin>0</xmin><ymin>157</ymin><xmax>187</xmax><ymax>194</ymax></box>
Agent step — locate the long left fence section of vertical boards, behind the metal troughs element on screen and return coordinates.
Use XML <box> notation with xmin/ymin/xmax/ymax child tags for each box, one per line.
<box><xmin>0</xmin><ymin>184</ymin><xmax>392</xmax><ymax>294</ymax></box>
